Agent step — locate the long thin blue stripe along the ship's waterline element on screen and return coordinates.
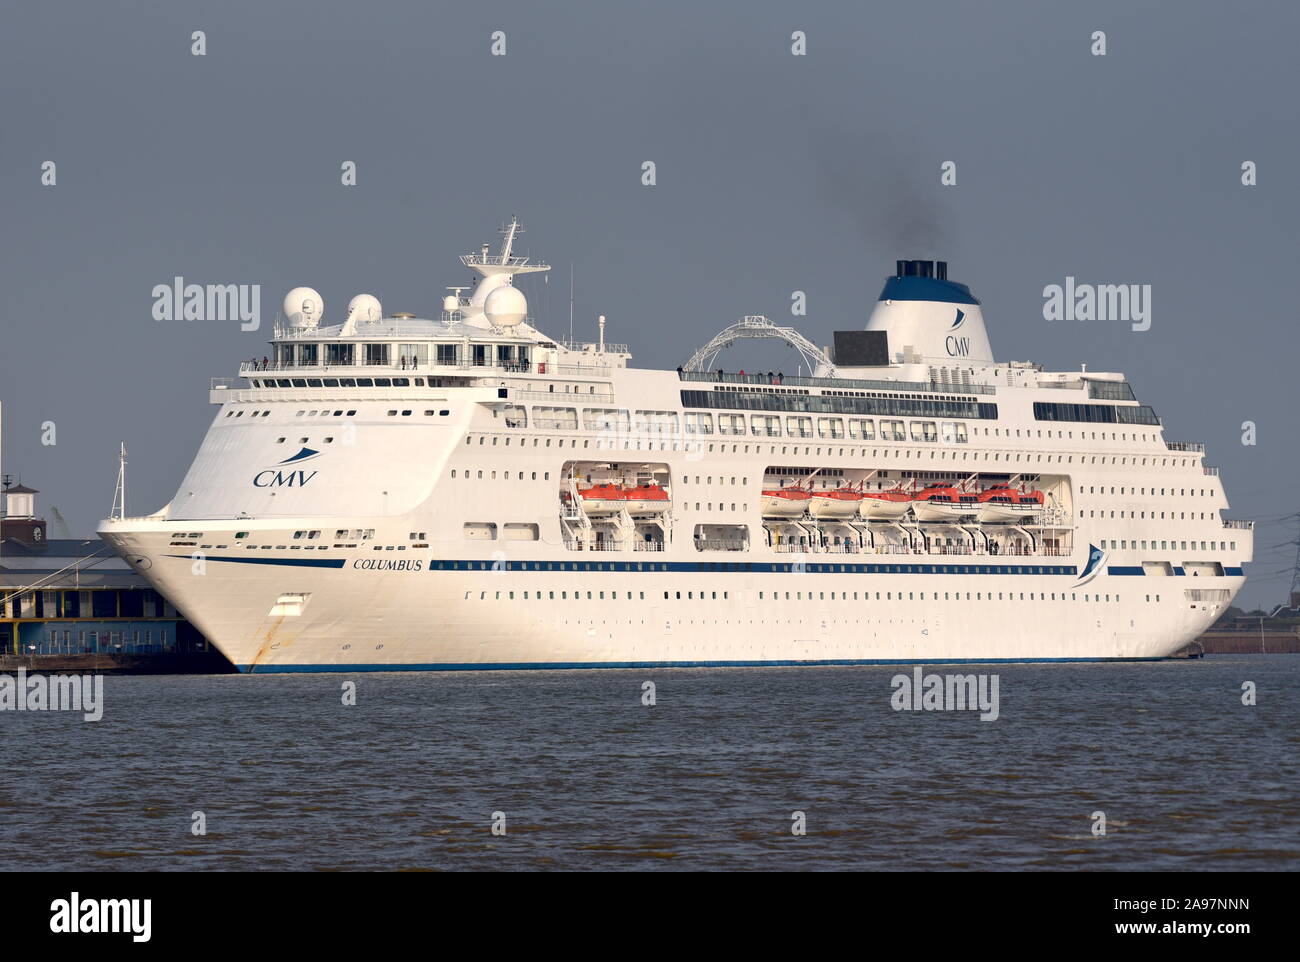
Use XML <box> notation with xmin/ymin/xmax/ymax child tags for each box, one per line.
<box><xmin>235</xmin><ymin>655</ymin><xmax>1167</xmax><ymax>675</ymax></box>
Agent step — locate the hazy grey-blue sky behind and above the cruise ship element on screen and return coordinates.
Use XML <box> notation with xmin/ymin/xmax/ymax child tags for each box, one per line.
<box><xmin>0</xmin><ymin>0</ymin><xmax>1300</xmax><ymax>605</ymax></box>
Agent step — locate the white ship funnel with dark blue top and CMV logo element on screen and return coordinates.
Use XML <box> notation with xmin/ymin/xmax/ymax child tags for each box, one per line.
<box><xmin>867</xmin><ymin>260</ymin><xmax>993</xmax><ymax>364</ymax></box>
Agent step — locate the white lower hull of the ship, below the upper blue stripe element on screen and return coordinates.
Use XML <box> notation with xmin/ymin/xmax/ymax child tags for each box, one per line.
<box><xmin>94</xmin><ymin>523</ymin><xmax>1242</xmax><ymax>672</ymax></box>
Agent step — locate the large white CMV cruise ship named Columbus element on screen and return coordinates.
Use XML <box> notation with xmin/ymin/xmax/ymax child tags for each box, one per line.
<box><xmin>100</xmin><ymin>218</ymin><xmax>1253</xmax><ymax>672</ymax></box>
